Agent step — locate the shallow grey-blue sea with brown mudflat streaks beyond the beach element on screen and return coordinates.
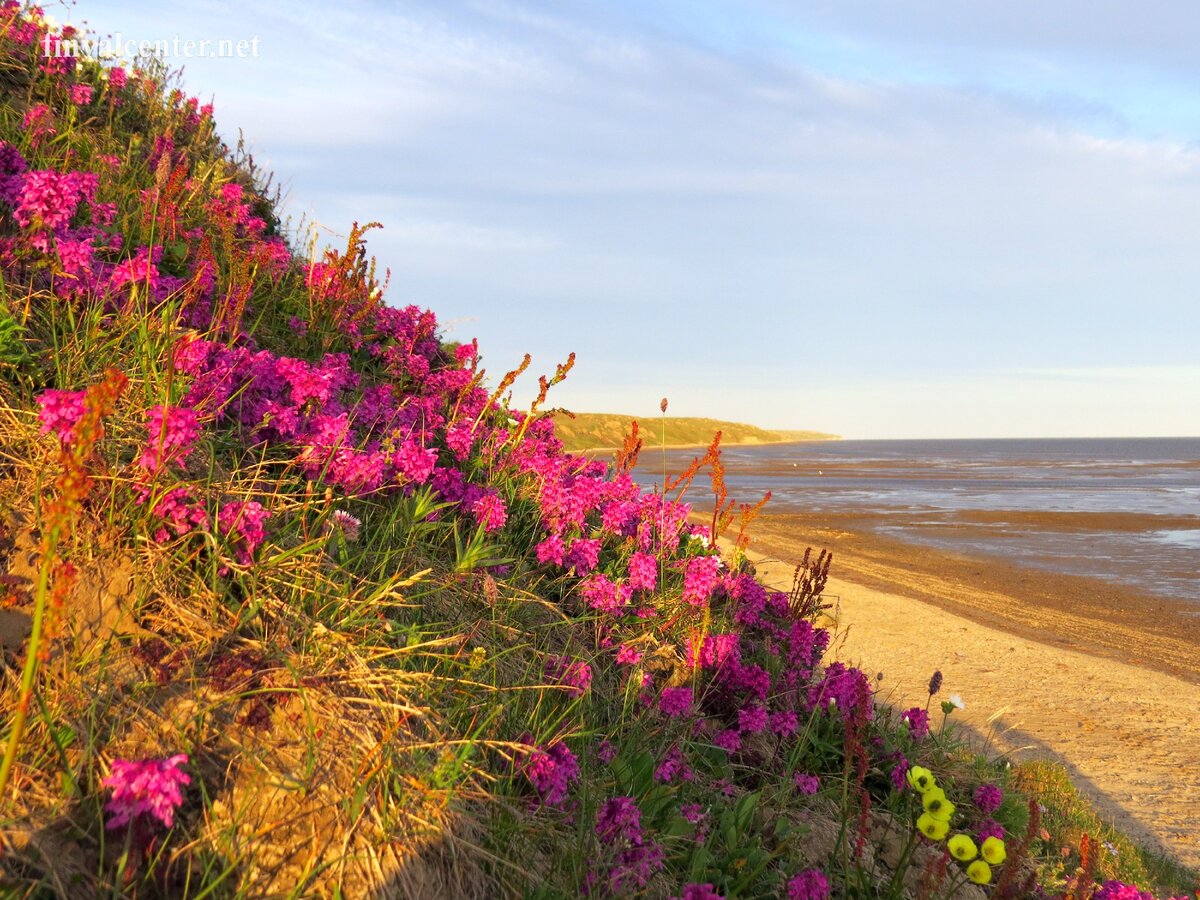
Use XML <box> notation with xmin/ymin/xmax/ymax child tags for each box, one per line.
<box><xmin>638</xmin><ymin>438</ymin><xmax>1200</xmax><ymax>607</ymax></box>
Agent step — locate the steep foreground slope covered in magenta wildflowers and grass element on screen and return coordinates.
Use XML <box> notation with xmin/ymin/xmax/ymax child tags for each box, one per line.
<box><xmin>0</xmin><ymin>2</ymin><xmax>1193</xmax><ymax>900</ymax></box>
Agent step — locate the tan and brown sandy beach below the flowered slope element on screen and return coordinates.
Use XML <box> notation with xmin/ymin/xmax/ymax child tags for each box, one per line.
<box><xmin>750</xmin><ymin>515</ymin><xmax>1200</xmax><ymax>866</ymax></box>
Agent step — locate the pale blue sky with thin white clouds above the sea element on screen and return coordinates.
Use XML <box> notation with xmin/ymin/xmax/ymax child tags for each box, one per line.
<box><xmin>77</xmin><ymin>0</ymin><xmax>1200</xmax><ymax>438</ymax></box>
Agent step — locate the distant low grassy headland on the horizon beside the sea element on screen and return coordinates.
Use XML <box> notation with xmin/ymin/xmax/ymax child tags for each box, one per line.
<box><xmin>554</xmin><ymin>413</ymin><xmax>836</xmax><ymax>452</ymax></box>
